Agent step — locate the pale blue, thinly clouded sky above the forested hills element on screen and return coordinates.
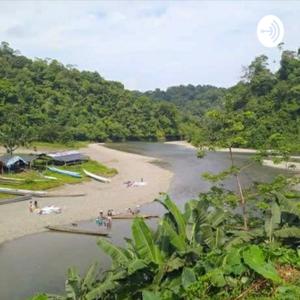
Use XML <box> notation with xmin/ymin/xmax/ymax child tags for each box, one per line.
<box><xmin>0</xmin><ymin>0</ymin><xmax>300</xmax><ymax>91</ymax></box>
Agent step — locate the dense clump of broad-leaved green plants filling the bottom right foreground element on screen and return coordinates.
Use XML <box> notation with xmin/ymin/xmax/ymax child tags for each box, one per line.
<box><xmin>37</xmin><ymin>186</ymin><xmax>300</xmax><ymax>300</ymax></box>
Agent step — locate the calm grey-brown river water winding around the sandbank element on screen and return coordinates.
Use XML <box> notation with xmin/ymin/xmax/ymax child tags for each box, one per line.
<box><xmin>0</xmin><ymin>142</ymin><xmax>288</xmax><ymax>300</ymax></box>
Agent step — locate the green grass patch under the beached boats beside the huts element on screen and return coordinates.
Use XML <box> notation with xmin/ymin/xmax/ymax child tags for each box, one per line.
<box><xmin>0</xmin><ymin>160</ymin><xmax>118</xmax><ymax>199</ymax></box>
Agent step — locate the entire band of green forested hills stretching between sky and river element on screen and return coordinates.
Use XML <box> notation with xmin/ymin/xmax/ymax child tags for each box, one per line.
<box><xmin>0</xmin><ymin>42</ymin><xmax>300</xmax><ymax>147</ymax></box>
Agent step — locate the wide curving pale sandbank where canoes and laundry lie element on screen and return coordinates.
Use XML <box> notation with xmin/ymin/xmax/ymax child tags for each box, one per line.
<box><xmin>0</xmin><ymin>144</ymin><xmax>172</xmax><ymax>243</ymax></box>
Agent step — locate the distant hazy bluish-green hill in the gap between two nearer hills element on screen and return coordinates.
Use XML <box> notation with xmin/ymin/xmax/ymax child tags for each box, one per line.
<box><xmin>138</xmin><ymin>84</ymin><xmax>226</xmax><ymax>116</ymax></box>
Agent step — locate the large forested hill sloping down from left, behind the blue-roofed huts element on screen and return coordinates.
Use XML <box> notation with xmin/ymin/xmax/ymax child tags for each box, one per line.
<box><xmin>0</xmin><ymin>42</ymin><xmax>179</xmax><ymax>142</ymax></box>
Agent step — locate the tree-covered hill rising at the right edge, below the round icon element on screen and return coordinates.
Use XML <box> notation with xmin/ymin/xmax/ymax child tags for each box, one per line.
<box><xmin>186</xmin><ymin>51</ymin><xmax>300</xmax><ymax>153</ymax></box>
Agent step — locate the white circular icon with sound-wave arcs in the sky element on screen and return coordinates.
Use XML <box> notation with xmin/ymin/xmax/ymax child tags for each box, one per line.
<box><xmin>256</xmin><ymin>15</ymin><xmax>284</xmax><ymax>48</ymax></box>
